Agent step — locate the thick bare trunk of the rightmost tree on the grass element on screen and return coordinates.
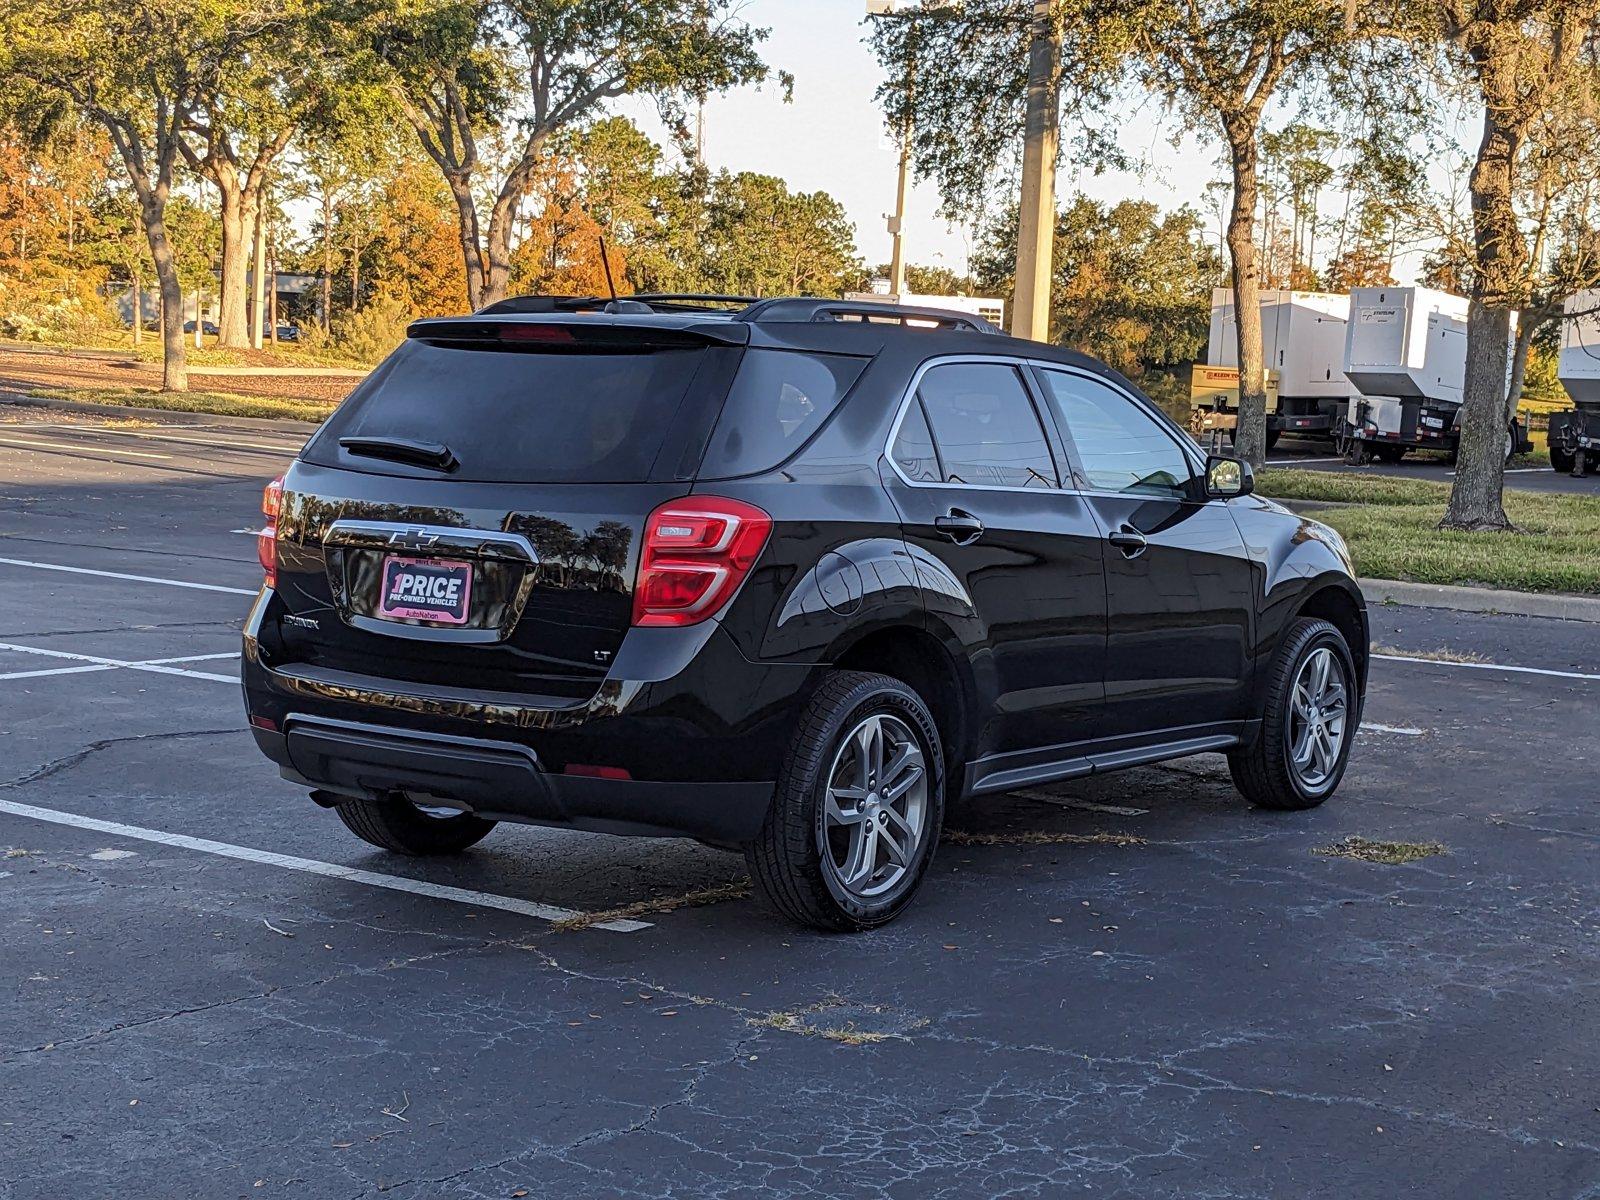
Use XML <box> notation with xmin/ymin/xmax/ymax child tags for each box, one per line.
<box><xmin>1440</xmin><ymin>106</ymin><xmax>1528</xmax><ymax>530</ymax></box>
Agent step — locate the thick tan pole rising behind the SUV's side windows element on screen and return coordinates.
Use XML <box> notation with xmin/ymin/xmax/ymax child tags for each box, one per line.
<box><xmin>1011</xmin><ymin>0</ymin><xmax>1061</xmax><ymax>342</ymax></box>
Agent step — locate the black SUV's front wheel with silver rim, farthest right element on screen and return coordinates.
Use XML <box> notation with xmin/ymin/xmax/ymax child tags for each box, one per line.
<box><xmin>1227</xmin><ymin>618</ymin><xmax>1360</xmax><ymax>810</ymax></box>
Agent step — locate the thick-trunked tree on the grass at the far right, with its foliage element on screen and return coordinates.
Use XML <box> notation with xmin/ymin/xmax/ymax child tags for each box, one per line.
<box><xmin>1430</xmin><ymin>0</ymin><xmax>1600</xmax><ymax>530</ymax></box>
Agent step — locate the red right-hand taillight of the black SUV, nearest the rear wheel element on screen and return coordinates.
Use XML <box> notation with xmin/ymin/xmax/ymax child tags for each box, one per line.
<box><xmin>634</xmin><ymin>496</ymin><xmax>773</xmax><ymax>626</ymax></box>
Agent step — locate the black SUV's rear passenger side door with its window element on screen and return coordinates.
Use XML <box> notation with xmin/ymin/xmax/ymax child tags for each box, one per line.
<box><xmin>886</xmin><ymin>358</ymin><xmax>1106</xmax><ymax>754</ymax></box>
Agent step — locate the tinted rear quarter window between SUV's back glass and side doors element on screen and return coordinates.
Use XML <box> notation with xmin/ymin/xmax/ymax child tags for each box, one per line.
<box><xmin>701</xmin><ymin>350</ymin><xmax>867</xmax><ymax>477</ymax></box>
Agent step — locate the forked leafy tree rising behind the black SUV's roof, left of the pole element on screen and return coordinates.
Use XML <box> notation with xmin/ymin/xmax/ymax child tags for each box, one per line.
<box><xmin>371</xmin><ymin>0</ymin><xmax>780</xmax><ymax>309</ymax></box>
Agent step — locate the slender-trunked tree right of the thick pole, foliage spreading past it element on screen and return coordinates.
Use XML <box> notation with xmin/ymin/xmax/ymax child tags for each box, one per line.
<box><xmin>872</xmin><ymin>0</ymin><xmax>1368</xmax><ymax>462</ymax></box>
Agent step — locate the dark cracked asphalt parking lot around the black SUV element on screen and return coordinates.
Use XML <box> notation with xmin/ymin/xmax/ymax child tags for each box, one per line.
<box><xmin>0</xmin><ymin>410</ymin><xmax>1600</xmax><ymax>1200</ymax></box>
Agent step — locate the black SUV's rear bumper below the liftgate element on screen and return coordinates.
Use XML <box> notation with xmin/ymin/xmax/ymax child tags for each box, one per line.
<box><xmin>242</xmin><ymin>592</ymin><xmax>814</xmax><ymax>843</ymax></box>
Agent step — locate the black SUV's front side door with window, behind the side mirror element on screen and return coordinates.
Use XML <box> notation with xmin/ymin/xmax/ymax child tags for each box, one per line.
<box><xmin>1035</xmin><ymin>363</ymin><xmax>1256</xmax><ymax>741</ymax></box>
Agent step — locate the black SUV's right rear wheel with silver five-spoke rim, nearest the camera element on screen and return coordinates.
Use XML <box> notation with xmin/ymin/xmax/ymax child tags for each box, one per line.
<box><xmin>746</xmin><ymin>670</ymin><xmax>944</xmax><ymax>931</ymax></box>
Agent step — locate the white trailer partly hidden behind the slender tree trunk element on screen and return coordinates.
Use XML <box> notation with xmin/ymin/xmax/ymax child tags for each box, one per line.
<box><xmin>1194</xmin><ymin>288</ymin><xmax>1355</xmax><ymax>445</ymax></box>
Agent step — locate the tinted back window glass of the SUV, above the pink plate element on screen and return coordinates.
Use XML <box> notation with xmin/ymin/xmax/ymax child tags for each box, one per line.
<box><xmin>302</xmin><ymin>341</ymin><xmax>706</xmax><ymax>483</ymax></box>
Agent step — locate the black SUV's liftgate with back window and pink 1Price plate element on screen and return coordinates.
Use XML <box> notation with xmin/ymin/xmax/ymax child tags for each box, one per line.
<box><xmin>278</xmin><ymin>322</ymin><xmax>739</xmax><ymax>701</ymax></box>
